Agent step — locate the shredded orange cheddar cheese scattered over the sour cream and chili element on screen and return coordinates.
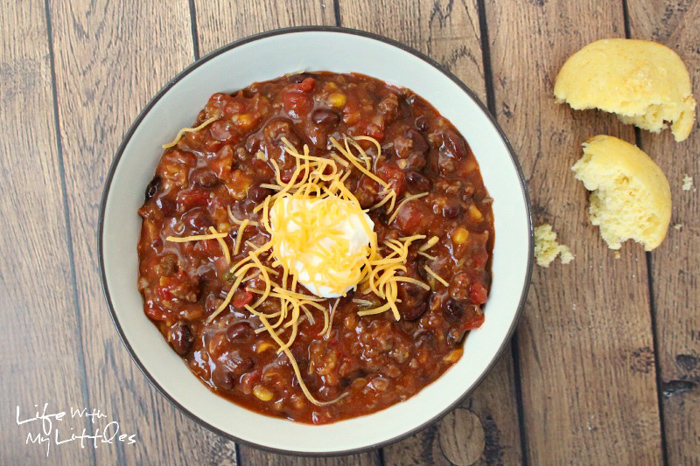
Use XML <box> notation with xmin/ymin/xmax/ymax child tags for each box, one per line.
<box><xmin>167</xmin><ymin>133</ymin><xmax>446</xmax><ymax>406</ymax></box>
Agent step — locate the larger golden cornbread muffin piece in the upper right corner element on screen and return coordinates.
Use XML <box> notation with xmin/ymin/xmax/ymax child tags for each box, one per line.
<box><xmin>554</xmin><ymin>39</ymin><xmax>695</xmax><ymax>142</ymax></box>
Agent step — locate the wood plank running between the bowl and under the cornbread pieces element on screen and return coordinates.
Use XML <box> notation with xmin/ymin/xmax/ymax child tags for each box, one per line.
<box><xmin>486</xmin><ymin>0</ymin><xmax>662</xmax><ymax>465</ymax></box>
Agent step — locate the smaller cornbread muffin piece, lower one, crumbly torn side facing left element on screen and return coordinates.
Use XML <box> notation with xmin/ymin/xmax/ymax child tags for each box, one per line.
<box><xmin>572</xmin><ymin>136</ymin><xmax>671</xmax><ymax>251</ymax></box>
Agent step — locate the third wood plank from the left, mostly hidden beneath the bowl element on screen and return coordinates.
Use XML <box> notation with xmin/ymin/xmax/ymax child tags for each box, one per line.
<box><xmin>195</xmin><ymin>0</ymin><xmax>372</xmax><ymax>466</ymax></box>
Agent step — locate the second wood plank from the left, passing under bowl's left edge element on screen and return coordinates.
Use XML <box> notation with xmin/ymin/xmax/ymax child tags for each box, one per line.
<box><xmin>50</xmin><ymin>0</ymin><xmax>235</xmax><ymax>464</ymax></box>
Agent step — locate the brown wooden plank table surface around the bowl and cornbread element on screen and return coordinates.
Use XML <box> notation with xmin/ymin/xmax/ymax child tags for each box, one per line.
<box><xmin>0</xmin><ymin>0</ymin><xmax>700</xmax><ymax>465</ymax></box>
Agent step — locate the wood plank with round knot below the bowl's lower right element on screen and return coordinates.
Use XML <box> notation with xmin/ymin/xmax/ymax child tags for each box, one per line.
<box><xmin>339</xmin><ymin>0</ymin><xmax>521</xmax><ymax>464</ymax></box>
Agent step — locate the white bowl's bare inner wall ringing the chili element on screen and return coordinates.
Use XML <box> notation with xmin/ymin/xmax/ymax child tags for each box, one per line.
<box><xmin>99</xmin><ymin>27</ymin><xmax>533</xmax><ymax>455</ymax></box>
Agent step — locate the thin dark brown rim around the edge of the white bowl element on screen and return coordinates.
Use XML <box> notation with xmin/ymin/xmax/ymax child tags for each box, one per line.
<box><xmin>97</xmin><ymin>26</ymin><xmax>534</xmax><ymax>457</ymax></box>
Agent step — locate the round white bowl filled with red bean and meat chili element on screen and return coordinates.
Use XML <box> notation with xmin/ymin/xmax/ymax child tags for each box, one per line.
<box><xmin>99</xmin><ymin>27</ymin><xmax>533</xmax><ymax>455</ymax></box>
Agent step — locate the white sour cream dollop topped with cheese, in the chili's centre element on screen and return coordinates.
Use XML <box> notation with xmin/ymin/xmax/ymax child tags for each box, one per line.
<box><xmin>270</xmin><ymin>197</ymin><xmax>374</xmax><ymax>298</ymax></box>
